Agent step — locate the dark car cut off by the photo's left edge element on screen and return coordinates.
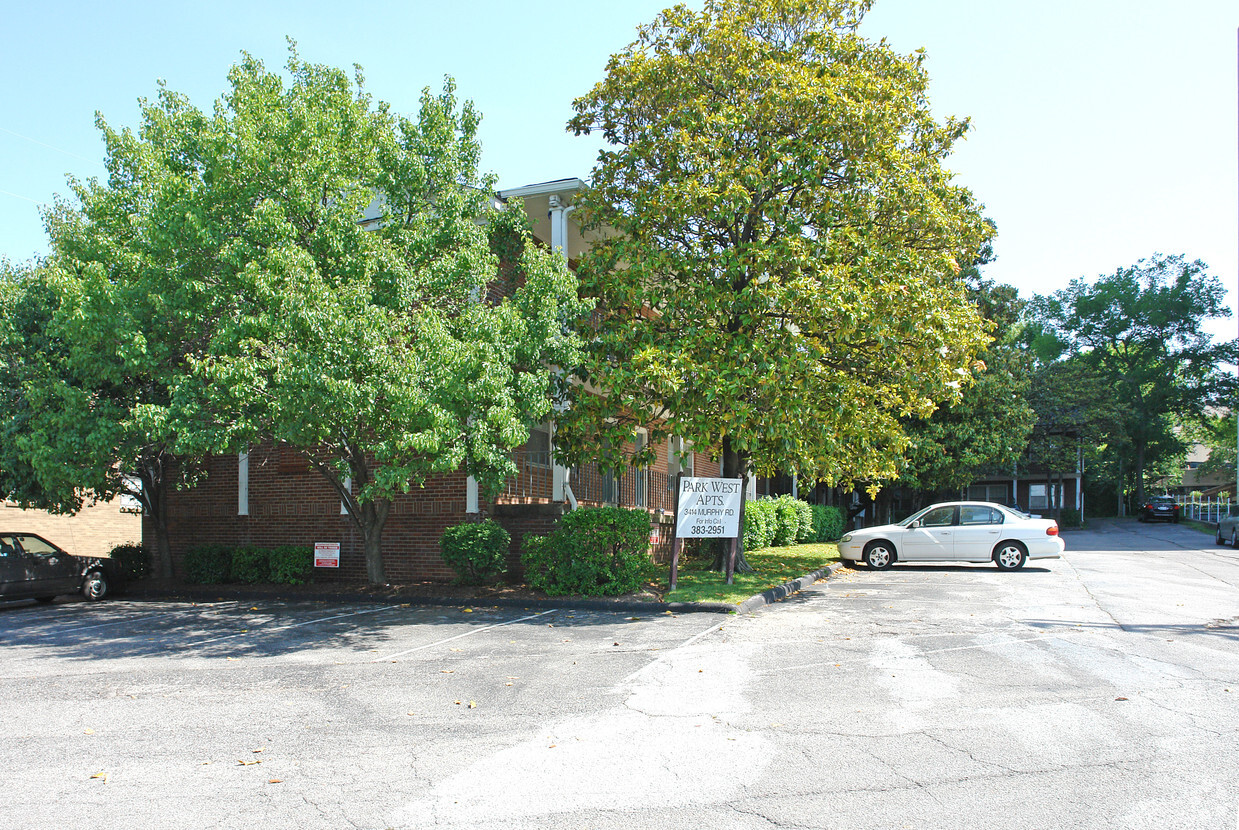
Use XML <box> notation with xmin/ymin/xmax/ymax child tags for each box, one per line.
<box><xmin>0</xmin><ymin>533</ymin><xmax>112</xmax><ymax>602</ymax></box>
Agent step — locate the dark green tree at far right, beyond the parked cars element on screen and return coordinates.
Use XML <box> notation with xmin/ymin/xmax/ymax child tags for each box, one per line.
<box><xmin>1031</xmin><ymin>254</ymin><xmax>1239</xmax><ymax>503</ymax></box>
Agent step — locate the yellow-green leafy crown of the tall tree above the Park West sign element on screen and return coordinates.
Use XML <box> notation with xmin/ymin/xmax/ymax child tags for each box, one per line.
<box><xmin>558</xmin><ymin>0</ymin><xmax>989</xmax><ymax>564</ymax></box>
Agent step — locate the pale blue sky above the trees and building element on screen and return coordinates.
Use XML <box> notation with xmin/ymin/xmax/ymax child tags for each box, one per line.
<box><xmin>0</xmin><ymin>0</ymin><xmax>1239</xmax><ymax>336</ymax></box>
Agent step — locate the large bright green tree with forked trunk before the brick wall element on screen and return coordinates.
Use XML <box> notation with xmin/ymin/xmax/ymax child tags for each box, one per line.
<box><xmin>25</xmin><ymin>50</ymin><xmax>579</xmax><ymax>582</ymax></box>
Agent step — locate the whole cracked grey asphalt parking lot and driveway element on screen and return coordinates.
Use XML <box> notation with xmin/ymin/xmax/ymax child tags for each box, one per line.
<box><xmin>0</xmin><ymin>522</ymin><xmax>1239</xmax><ymax>830</ymax></box>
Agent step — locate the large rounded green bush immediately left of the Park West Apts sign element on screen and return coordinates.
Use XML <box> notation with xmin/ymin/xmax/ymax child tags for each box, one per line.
<box><xmin>520</xmin><ymin>507</ymin><xmax>653</xmax><ymax>596</ymax></box>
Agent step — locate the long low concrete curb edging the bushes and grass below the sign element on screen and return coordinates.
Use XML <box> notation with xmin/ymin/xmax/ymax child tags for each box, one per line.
<box><xmin>128</xmin><ymin>562</ymin><xmax>843</xmax><ymax>614</ymax></box>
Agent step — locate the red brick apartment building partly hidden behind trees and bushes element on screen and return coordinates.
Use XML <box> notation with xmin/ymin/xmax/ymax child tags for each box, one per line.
<box><xmin>144</xmin><ymin>178</ymin><xmax>720</xmax><ymax>583</ymax></box>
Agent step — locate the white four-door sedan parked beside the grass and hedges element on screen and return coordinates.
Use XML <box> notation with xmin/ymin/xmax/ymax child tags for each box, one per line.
<box><xmin>839</xmin><ymin>502</ymin><xmax>1066</xmax><ymax>571</ymax></box>
